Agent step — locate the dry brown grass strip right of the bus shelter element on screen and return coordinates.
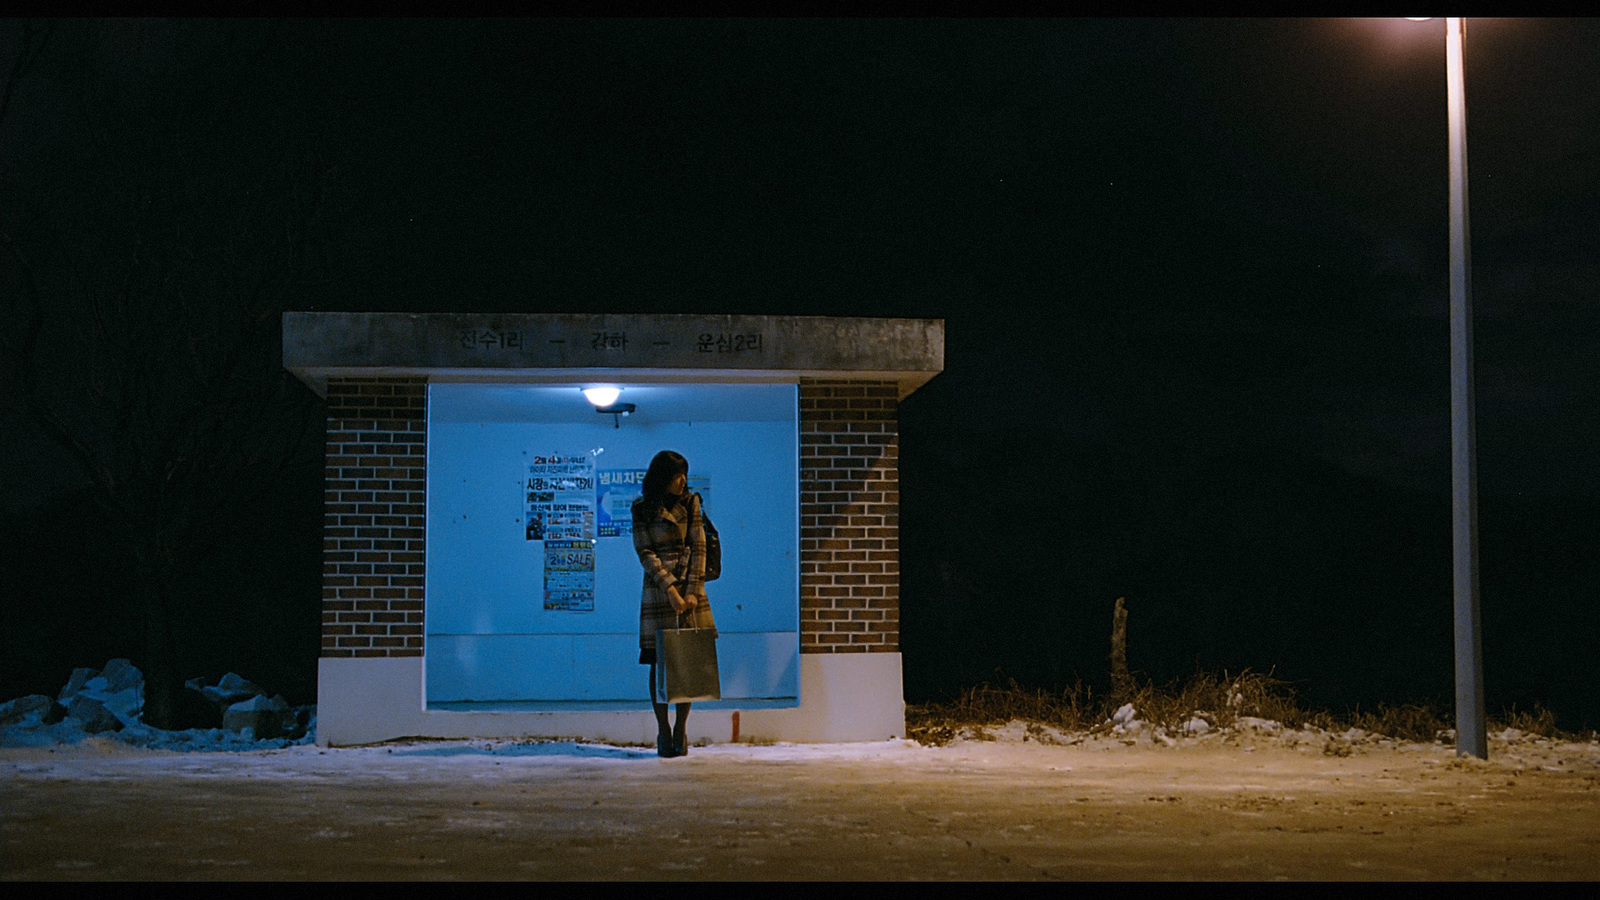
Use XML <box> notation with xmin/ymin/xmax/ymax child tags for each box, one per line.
<box><xmin>906</xmin><ymin>671</ymin><xmax>1592</xmax><ymax>746</ymax></box>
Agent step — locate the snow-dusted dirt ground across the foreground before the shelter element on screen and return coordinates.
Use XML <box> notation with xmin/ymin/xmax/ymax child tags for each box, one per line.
<box><xmin>0</xmin><ymin>724</ymin><xmax>1600</xmax><ymax>881</ymax></box>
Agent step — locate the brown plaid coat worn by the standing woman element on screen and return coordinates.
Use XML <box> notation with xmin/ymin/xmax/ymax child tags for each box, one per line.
<box><xmin>634</xmin><ymin>493</ymin><xmax>717</xmax><ymax>650</ymax></box>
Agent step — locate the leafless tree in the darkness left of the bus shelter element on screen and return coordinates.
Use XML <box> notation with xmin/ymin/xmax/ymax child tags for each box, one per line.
<box><xmin>0</xmin><ymin>21</ymin><xmax>333</xmax><ymax>725</ymax></box>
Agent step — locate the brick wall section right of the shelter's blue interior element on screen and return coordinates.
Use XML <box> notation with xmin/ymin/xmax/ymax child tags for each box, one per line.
<box><xmin>800</xmin><ymin>378</ymin><xmax>899</xmax><ymax>653</ymax></box>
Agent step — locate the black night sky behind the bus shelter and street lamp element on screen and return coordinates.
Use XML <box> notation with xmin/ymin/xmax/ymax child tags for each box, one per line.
<box><xmin>0</xmin><ymin>19</ymin><xmax>1600</xmax><ymax>727</ymax></box>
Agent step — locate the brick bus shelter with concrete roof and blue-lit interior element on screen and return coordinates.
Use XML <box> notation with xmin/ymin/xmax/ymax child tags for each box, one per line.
<box><xmin>283</xmin><ymin>312</ymin><xmax>944</xmax><ymax>745</ymax></box>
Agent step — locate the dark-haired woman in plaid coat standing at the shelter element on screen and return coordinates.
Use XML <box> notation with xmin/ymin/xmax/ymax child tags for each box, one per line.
<box><xmin>634</xmin><ymin>450</ymin><xmax>715</xmax><ymax>757</ymax></box>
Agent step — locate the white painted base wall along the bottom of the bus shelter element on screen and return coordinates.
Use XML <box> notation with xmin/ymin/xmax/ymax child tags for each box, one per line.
<box><xmin>317</xmin><ymin>653</ymin><xmax>906</xmax><ymax>746</ymax></box>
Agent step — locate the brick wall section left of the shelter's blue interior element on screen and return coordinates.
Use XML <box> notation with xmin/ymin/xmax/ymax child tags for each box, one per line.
<box><xmin>322</xmin><ymin>378</ymin><xmax>427</xmax><ymax>657</ymax></box>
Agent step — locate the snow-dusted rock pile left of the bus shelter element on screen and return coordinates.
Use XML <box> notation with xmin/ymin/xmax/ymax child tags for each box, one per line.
<box><xmin>0</xmin><ymin>660</ymin><xmax>317</xmax><ymax>751</ymax></box>
